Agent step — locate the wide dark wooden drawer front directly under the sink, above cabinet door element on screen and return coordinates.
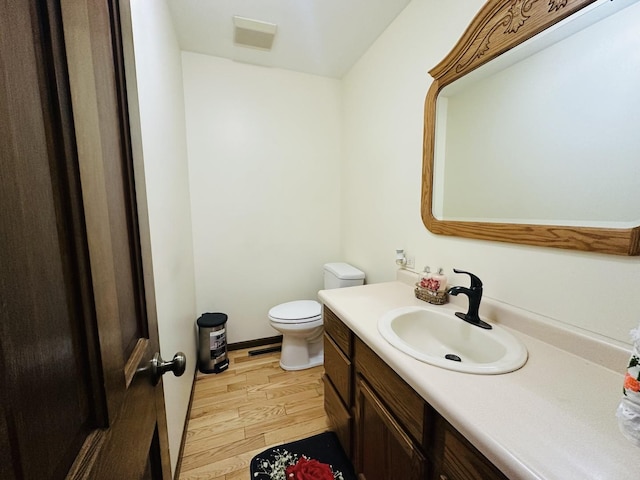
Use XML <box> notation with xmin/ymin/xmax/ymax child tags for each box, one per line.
<box><xmin>355</xmin><ymin>337</ymin><xmax>433</xmax><ymax>445</ymax></box>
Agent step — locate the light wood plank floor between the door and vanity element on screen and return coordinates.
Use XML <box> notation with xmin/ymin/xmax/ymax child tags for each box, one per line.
<box><xmin>180</xmin><ymin>347</ymin><xmax>329</xmax><ymax>480</ymax></box>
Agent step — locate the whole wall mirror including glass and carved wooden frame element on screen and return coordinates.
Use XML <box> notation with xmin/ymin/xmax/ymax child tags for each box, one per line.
<box><xmin>422</xmin><ymin>0</ymin><xmax>640</xmax><ymax>255</ymax></box>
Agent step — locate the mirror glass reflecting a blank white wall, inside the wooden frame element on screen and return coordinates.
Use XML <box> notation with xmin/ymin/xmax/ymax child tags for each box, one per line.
<box><xmin>432</xmin><ymin>2</ymin><xmax>640</xmax><ymax>228</ymax></box>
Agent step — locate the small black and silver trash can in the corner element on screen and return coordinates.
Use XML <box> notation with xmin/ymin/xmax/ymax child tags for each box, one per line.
<box><xmin>196</xmin><ymin>313</ymin><xmax>229</xmax><ymax>373</ymax></box>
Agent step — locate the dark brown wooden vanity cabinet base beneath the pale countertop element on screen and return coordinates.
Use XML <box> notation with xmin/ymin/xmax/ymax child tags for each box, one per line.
<box><xmin>323</xmin><ymin>307</ymin><xmax>508</xmax><ymax>480</ymax></box>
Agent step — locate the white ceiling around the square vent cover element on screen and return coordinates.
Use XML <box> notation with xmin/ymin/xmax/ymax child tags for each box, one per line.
<box><xmin>168</xmin><ymin>0</ymin><xmax>411</xmax><ymax>78</ymax></box>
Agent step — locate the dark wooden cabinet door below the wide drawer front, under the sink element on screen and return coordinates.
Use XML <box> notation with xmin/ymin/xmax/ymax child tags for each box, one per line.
<box><xmin>356</xmin><ymin>377</ymin><xmax>427</xmax><ymax>480</ymax></box>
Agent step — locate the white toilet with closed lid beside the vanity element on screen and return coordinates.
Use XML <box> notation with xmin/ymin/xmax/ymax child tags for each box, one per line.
<box><xmin>269</xmin><ymin>263</ymin><xmax>364</xmax><ymax>370</ymax></box>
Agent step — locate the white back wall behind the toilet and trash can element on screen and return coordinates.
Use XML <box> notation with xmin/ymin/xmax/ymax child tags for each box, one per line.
<box><xmin>182</xmin><ymin>52</ymin><xmax>341</xmax><ymax>343</ymax></box>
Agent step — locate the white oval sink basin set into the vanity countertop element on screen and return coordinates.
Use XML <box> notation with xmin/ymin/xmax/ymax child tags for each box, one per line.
<box><xmin>378</xmin><ymin>306</ymin><xmax>528</xmax><ymax>375</ymax></box>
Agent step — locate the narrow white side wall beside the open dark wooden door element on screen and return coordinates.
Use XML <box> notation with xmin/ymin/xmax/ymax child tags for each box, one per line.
<box><xmin>126</xmin><ymin>0</ymin><xmax>196</xmax><ymax>471</ymax></box>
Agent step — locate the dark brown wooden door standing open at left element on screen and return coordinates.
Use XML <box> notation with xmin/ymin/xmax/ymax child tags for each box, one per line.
<box><xmin>0</xmin><ymin>0</ymin><xmax>170</xmax><ymax>479</ymax></box>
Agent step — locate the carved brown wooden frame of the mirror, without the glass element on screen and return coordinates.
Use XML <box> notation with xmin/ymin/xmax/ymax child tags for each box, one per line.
<box><xmin>421</xmin><ymin>0</ymin><xmax>640</xmax><ymax>255</ymax></box>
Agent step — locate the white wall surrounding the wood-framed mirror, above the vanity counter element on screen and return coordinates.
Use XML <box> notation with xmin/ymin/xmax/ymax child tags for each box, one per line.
<box><xmin>342</xmin><ymin>0</ymin><xmax>640</xmax><ymax>343</ymax></box>
